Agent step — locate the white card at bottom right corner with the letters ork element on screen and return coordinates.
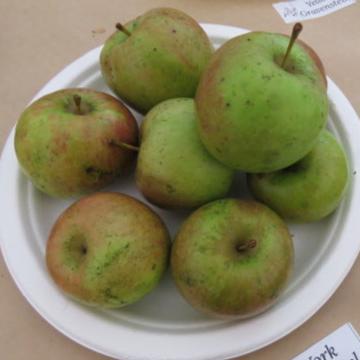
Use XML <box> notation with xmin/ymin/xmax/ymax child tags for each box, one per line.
<box><xmin>293</xmin><ymin>323</ymin><xmax>360</xmax><ymax>360</ymax></box>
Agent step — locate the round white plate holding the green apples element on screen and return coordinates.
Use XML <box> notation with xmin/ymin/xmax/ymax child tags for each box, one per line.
<box><xmin>0</xmin><ymin>25</ymin><xmax>360</xmax><ymax>360</ymax></box>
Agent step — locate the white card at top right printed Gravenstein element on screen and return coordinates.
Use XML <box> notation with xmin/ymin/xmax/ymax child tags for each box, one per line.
<box><xmin>273</xmin><ymin>0</ymin><xmax>356</xmax><ymax>24</ymax></box>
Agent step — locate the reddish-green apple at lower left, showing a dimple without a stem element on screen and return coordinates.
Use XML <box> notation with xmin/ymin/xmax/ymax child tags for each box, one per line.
<box><xmin>46</xmin><ymin>192</ymin><xmax>170</xmax><ymax>308</ymax></box>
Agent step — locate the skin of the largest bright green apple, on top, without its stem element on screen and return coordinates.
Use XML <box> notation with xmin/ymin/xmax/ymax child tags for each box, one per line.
<box><xmin>196</xmin><ymin>32</ymin><xmax>328</xmax><ymax>173</ymax></box>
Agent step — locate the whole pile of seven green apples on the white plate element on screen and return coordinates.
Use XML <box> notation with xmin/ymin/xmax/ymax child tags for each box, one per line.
<box><xmin>15</xmin><ymin>8</ymin><xmax>348</xmax><ymax>318</ymax></box>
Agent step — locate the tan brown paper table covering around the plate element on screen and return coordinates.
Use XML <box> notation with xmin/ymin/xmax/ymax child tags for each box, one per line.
<box><xmin>0</xmin><ymin>0</ymin><xmax>360</xmax><ymax>360</ymax></box>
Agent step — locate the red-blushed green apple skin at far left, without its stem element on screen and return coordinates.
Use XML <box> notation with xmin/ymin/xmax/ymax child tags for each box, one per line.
<box><xmin>15</xmin><ymin>88</ymin><xmax>138</xmax><ymax>197</ymax></box>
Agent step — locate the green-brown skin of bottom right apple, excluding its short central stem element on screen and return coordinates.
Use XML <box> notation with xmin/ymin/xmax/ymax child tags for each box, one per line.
<box><xmin>171</xmin><ymin>199</ymin><xmax>294</xmax><ymax>318</ymax></box>
